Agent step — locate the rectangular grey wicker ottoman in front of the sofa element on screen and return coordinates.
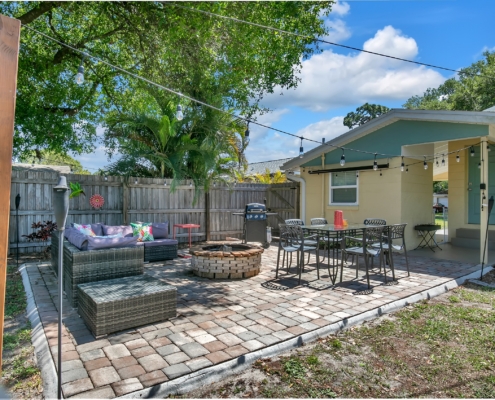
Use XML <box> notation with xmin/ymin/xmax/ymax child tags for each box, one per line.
<box><xmin>78</xmin><ymin>275</ymin><xmax>177</xmax><ymax>337</ymax></box>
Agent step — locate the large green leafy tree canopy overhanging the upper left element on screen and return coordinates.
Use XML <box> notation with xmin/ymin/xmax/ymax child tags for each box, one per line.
<box><xmin>0</xmin><ymin>1</ymin><xmax>333</xmax><ymax>156</ymax></box>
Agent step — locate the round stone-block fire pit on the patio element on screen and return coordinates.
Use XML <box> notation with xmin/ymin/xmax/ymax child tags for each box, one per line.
<box><xmin>189</xmin><ymin>242</ymin><xmax>263</xmax><ymax>279</ymax></box>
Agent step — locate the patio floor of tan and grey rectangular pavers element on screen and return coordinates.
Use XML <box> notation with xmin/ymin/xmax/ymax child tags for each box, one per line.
<box><xmin>22</xmin><ymin>246</ymin><xmax>478</xmax><ymax>398</ymax></box>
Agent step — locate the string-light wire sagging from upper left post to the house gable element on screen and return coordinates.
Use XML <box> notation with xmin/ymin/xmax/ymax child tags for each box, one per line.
<box><xmin>22</xmin><ymin>25</ymin><xmax>492</xmax><ymax>160</ymax></box>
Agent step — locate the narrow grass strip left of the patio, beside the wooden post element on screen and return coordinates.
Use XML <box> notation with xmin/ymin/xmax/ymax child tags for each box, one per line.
<box><xmin>2</xmin><ymin>260</ymin><xmax>42</xmax><ymax>399</ymax></box>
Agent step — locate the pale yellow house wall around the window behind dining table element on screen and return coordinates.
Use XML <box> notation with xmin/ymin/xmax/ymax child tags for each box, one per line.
<box><xmin>301</xmin><ymin>158</ymin><xmax>433</xmax><ymax>249</ymax></box>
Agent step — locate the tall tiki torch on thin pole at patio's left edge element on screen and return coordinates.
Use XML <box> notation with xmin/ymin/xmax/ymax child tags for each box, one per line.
<box><xmin>53</xmin><ymin>176</ymin><xmax>69</xmax><ymax>399</ymax></box>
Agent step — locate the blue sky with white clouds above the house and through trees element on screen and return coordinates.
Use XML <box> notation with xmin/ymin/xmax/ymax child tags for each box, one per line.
<box><xmin>76</xmin><ymin>0</ymin><xmax>495</xmax><ymax>172</ymax></box>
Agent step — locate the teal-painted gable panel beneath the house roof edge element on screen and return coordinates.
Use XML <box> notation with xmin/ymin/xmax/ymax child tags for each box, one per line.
<box><xmin>301</xmin><ymin>120</ymin><xmax>488</xmax><ymax>167</ymax></box>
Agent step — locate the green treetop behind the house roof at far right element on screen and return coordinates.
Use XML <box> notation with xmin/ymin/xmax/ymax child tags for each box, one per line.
<box><xmin>403</xmin><ymin>51</ymin><xmax>495</xmax><ymax>111</ymax></box>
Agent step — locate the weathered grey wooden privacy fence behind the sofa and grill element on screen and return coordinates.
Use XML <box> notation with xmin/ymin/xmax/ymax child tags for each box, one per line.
<box><xmin>9</xmin><ymin>170</ymin><xmax>299</xmax><ymax>253</ymax></box>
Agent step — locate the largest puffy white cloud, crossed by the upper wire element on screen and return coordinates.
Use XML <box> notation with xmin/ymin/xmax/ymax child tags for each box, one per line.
<box><xmin>263</xmin><ymin>26</ymin><xmax>445</xmax><ymax>111</ymax></box>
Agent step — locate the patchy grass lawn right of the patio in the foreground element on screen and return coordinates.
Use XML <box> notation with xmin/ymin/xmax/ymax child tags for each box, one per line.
<box><xmin>184</xmin><ymin>273</ymin><xmax>495</xmax><ymax>398</ymax></box>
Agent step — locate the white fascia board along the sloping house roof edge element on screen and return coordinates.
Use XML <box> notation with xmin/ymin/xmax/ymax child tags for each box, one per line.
<box><xmin>280</xmin><ymin>108</ymin><xmax>495</xmax><ymax>170</ymax></box>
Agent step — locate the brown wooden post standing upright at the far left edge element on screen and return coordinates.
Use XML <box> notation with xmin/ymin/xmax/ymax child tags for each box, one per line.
<box><xmin>0</xmin><ymin>14</ymin><xmax>21</xmax><ymax>371</ymax></box>
